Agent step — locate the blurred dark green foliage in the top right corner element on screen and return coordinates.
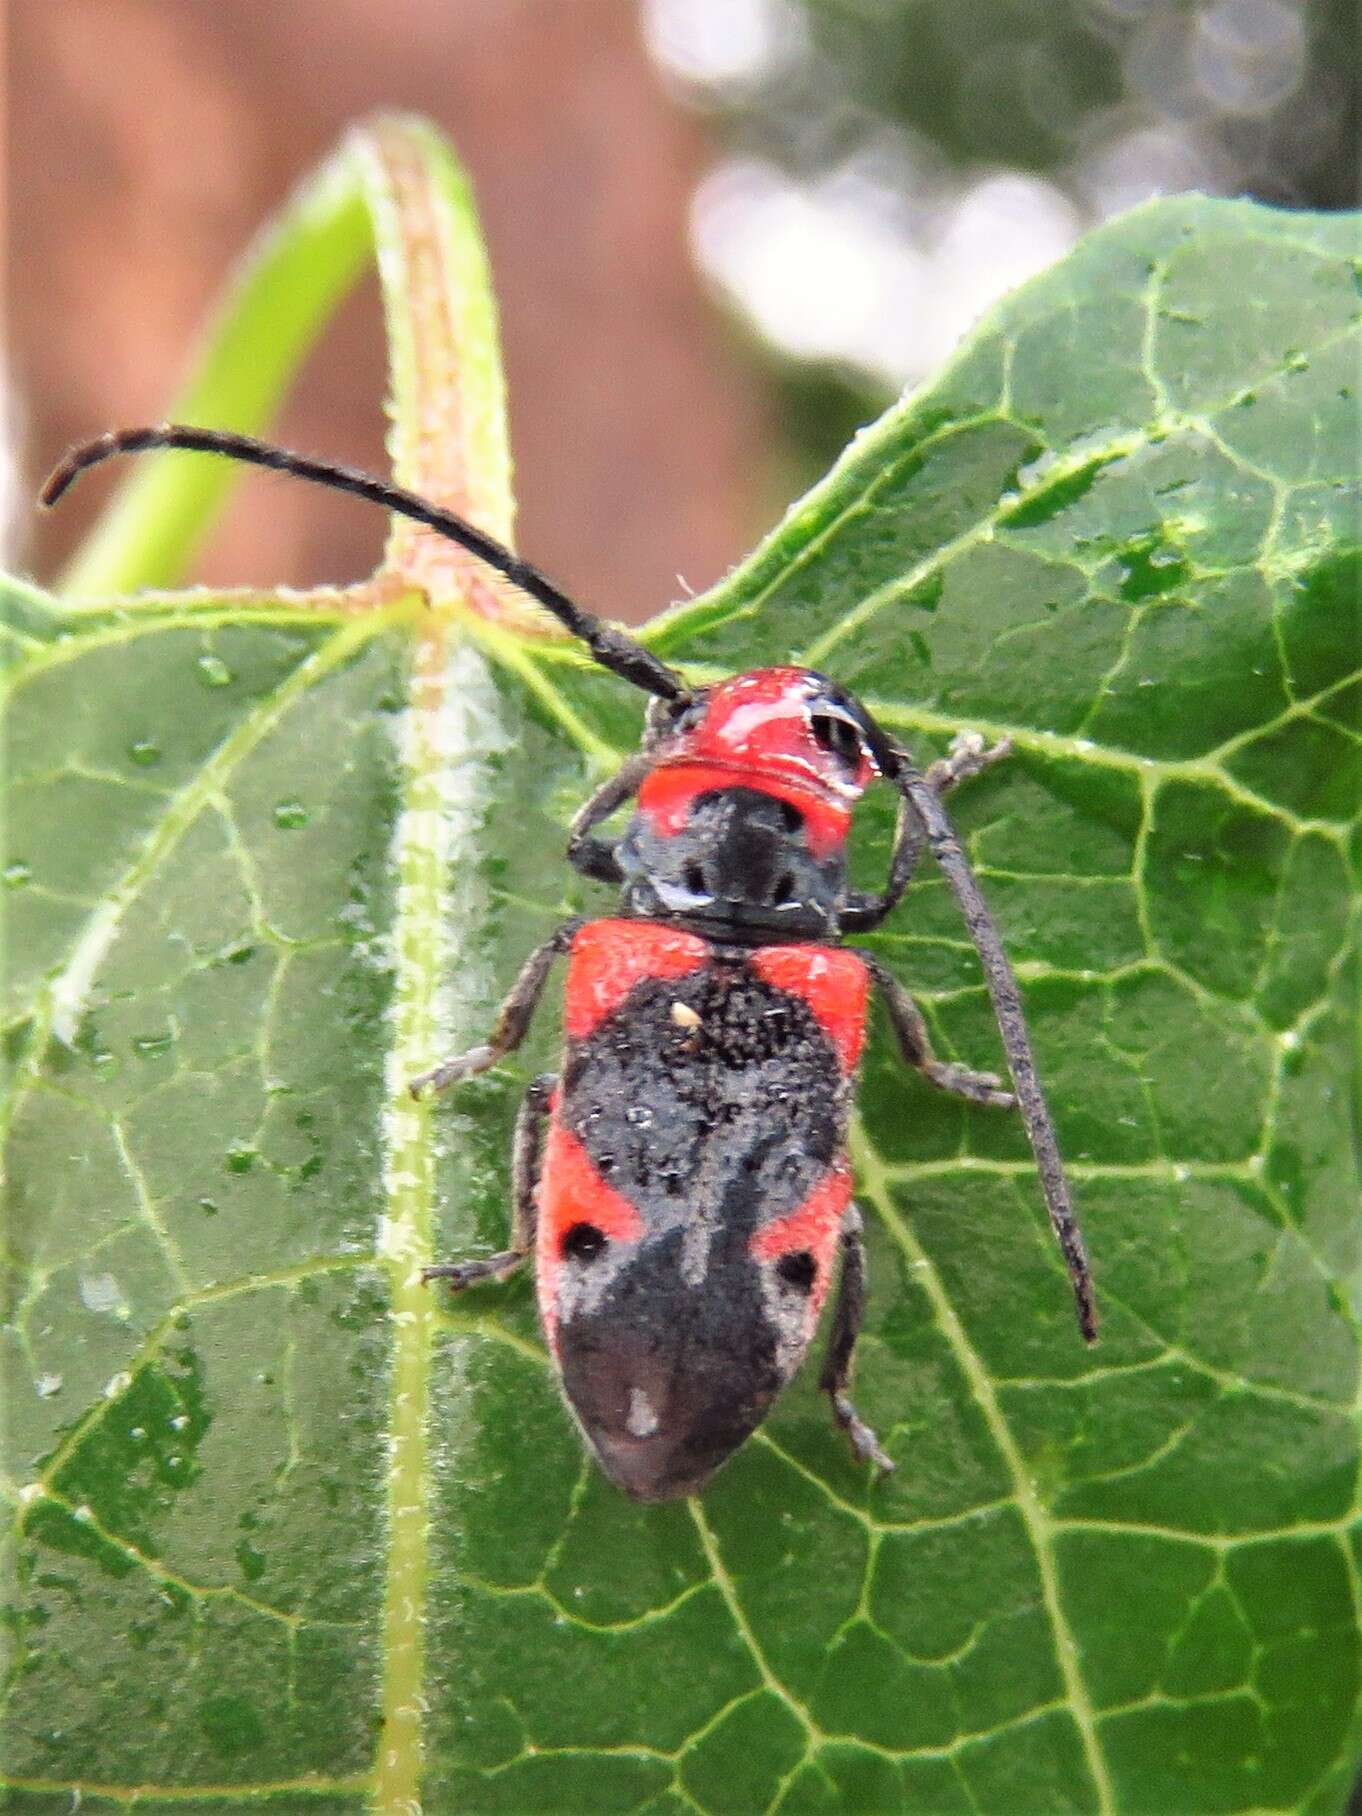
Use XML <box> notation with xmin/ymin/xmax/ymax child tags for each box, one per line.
<box><xmin>777</xmin><ymin>0</ymin><xmax>1360</xmax><ymax>209</ymax></box>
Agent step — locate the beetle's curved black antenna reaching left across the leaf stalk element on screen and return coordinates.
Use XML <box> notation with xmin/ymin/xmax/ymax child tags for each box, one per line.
<box><xmin>42</xmin><ymin>423</ymin><xmax>690</xmax><ymax>701</ymax></box>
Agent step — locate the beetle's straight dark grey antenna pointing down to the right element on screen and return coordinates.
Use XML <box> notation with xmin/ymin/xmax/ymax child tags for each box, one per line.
<box><xmin>881</xmin><ymin>739</ymin><xmax>1097</xmax><ymax>1344</ymax></box>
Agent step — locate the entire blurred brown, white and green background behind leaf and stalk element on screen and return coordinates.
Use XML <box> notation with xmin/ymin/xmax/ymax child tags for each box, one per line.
<box><xmin>4</xmin><ymin>0</ymin><xmax>1360</xmax><ymax>619</ymax></box>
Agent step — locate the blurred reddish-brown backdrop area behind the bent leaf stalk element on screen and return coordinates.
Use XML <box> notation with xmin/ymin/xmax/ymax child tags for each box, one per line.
<box><xmin>7</xmin><ymin>0</ymin><xmax>766</xmax><ymax>619</ymax></box>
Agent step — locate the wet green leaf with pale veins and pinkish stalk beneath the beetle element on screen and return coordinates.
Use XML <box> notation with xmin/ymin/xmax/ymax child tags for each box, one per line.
<box><xmin>5</xmin><ymin>123</ymin><xmax>1362</xmax><ymax>1812</ymax></box>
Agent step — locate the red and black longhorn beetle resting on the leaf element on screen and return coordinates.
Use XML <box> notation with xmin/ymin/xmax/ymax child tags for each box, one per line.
<box><xmin>42</xmin><ymin>423</ymin><xmax>1097</xmax><ymax>1500</ymax></box>
